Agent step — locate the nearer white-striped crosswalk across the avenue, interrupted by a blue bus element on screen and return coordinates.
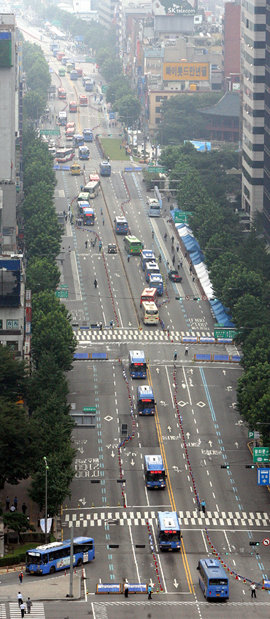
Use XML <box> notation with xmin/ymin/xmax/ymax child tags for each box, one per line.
<box><xmin>64</xmin><ymin>508</ymin><xmax>270</xmax><ymax>529</ymax></box>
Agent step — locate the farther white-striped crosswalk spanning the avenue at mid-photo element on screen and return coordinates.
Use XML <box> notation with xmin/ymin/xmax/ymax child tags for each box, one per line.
<box><xmin>73</xmin><ymin>328</ymin><xmax>214</xmax><ymax>344</ymax></box>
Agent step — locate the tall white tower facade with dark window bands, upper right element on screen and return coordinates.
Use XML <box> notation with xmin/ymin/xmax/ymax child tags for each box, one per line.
<box><xmin>241</xmin><ymin>0</ymin><xmax>268</xmax><ymax>220</ymax></box>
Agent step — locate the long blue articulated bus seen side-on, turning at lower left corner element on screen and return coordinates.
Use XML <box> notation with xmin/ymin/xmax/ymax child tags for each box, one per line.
<box><xmin>26</xmin><ymin>537</ymin><xmax>95</xmax><ymax>574</ymax></box>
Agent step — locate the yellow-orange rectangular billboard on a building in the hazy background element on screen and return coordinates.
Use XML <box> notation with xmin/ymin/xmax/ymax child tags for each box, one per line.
<box><xmin>163</xmin><ymin>62</ymin><xmax>209</xmax><ymax>82</ymax></box>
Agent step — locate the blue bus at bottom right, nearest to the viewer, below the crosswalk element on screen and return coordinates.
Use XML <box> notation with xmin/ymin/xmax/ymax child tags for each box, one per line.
<box><xmin>197</xmin><ymin>558</ymin><xmax>229</xmax><ymax>600</ymax></box>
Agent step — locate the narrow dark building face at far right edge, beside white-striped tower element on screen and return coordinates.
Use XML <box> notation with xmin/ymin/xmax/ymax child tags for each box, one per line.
<box><xmin>263</xmin><ymin>0</ymin><xmax>270</xmax><ymax>237</ymax></box>
